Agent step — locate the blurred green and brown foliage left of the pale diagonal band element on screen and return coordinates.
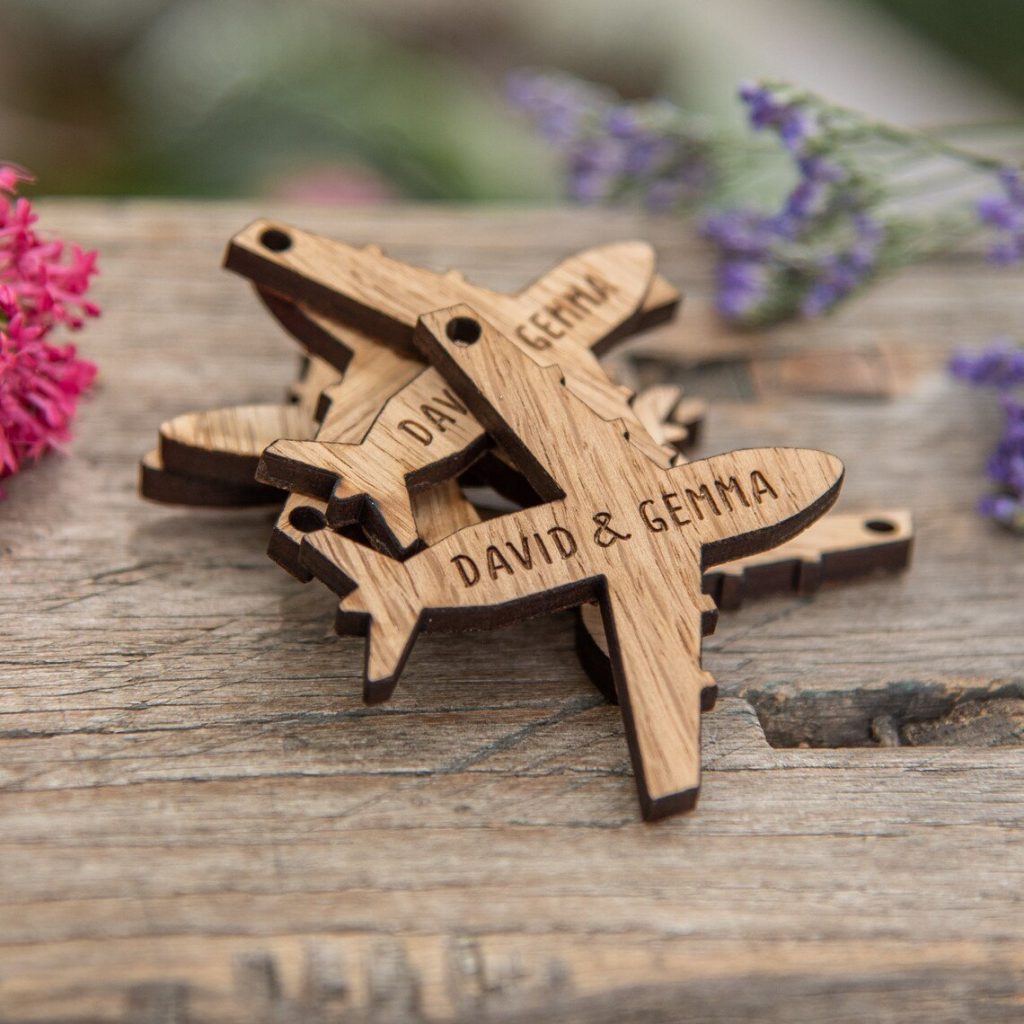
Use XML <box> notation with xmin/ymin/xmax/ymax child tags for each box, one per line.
<box><xmin>0</xmin><ymin>0</ymin><xmax>559</xmax><ymax>201</ymax></box>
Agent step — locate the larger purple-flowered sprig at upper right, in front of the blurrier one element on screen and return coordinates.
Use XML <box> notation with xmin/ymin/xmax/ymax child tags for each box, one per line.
<box><xmin>703</xmin><ymin>82</ymin><xmax>998</xmax><ymax>327</ymax></box>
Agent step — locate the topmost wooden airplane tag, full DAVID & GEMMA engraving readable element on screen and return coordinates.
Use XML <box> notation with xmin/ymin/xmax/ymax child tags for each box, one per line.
<box><xmin>302</xmin><ymin>306</ymin><xmax>843</xmax><ymax>818</ymax></box>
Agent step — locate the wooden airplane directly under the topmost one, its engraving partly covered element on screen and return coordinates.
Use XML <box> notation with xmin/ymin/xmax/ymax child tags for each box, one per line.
<box><xmin>225</xmin><ymin>221</ymin><xmax>679</xmax><ymax>555</ymax></box>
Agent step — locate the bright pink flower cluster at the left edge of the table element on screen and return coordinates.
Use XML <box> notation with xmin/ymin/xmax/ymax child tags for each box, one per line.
<box><xmin>0</xmin><ymin>165</ymin><xmax>99</xmax><ymax>498</ymax></box>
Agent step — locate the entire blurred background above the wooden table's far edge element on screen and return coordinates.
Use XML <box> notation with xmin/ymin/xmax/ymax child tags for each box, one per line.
<box><xmin>0</xmin><ymin>0</ymin><xmax>1024</xmax><ymax>203</ymax></box>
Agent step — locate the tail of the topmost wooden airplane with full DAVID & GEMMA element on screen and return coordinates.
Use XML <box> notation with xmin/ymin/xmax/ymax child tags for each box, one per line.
<box><xmin>302</xmin><ymin>529</ymin><xmax>422</xmax><ymax>703</ymax></box>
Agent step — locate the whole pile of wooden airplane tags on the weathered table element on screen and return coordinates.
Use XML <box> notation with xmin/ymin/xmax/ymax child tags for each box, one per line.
<box><xmin>141</xmin><ymin>221</ymin><xmax>911</xmax><ymax>818</ymax></box>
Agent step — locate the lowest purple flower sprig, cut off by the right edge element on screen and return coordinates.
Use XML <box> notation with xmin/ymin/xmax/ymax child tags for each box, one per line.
<box><xmin>949</xmin><ymin>338</ymin><xmax>1024</xmax><ymax>534</ymax></box>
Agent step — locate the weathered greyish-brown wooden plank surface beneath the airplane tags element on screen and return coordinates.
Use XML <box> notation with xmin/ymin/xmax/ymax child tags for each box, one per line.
<box><xmin>0</xmin><ymin>202</ymin><xmax>1024</xmax><ymax>1024</ymax></box>
